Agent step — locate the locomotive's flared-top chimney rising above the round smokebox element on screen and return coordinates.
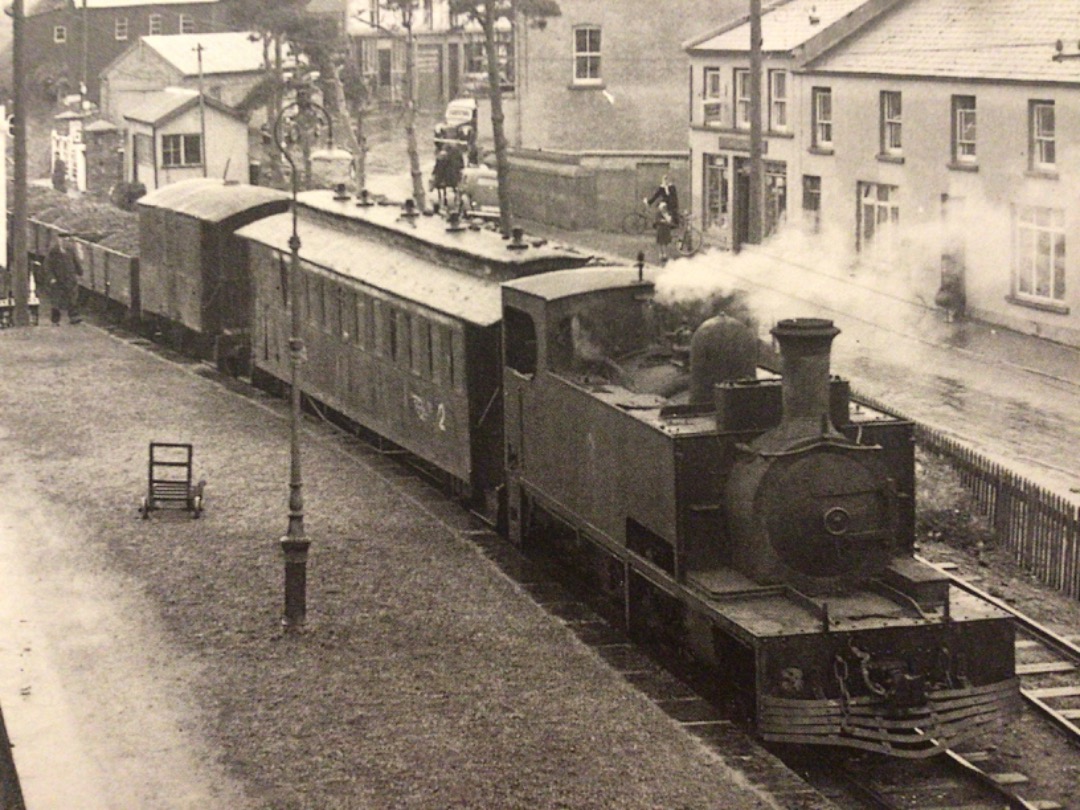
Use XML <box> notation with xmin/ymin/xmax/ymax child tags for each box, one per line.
<box><xmin>772</xmin><ymin>318</ymin><xmax>840</xmax><ymax>436</ymax></box>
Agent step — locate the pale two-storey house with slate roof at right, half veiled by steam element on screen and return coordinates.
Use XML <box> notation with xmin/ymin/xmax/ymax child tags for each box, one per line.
<box><xmin>793</xmin><ymin>0</ymin><xmax>1080</xmax><ymax>346</ymax></box>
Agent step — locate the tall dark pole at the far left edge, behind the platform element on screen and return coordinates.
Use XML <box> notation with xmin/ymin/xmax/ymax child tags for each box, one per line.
<box><xmin>11</xmin><ymin>0</ymin><xmax>30</xmax><ymax>326</ymax></box>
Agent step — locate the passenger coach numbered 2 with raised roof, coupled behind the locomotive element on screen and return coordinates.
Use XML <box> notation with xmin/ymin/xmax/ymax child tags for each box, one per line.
<box><xmin>238</xmin><ymin>191</ymin><xmax>591</xmax><ymax>510</ymax></box>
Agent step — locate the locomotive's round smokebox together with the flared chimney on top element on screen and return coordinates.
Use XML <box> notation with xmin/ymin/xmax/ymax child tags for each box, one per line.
<box><xmin>728</xmin><ymin>319</ymin><xmax>896</xmax><ymax>593</ymax></box>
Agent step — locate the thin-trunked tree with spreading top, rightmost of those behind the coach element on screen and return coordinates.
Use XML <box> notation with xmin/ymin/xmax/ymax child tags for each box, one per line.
<box><xmin>449</xmin><ymin>0</ymin><xmax>562</xmax><ymax>235</ymax></box>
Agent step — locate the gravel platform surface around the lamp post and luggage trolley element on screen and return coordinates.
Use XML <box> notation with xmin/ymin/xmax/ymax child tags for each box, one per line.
<box><xmin>0</xmin><ymin>324</ymin><xmax>812</xmax><ymax>810</ymax></box>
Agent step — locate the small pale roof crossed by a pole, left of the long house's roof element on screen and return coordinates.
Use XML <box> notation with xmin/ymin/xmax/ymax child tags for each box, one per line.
<box><xmin>688</xmin><ymin>0</ymin><xmax>867</xmax><ymax>53</ymax></box>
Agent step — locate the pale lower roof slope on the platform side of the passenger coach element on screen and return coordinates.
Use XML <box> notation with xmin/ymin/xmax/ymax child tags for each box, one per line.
<box><xmin>237</xmin><ymin>219</ymin><xmax>502</xmax><ymax>326</ymax></box>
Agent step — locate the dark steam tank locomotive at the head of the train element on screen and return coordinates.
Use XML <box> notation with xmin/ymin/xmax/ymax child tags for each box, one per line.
<box><xmin>503</xmin><ymin>268</ymin><xmax>1018</xmax><ymax>757</ymax></box>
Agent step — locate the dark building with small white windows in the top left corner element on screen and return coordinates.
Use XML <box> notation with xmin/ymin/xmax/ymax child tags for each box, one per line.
<box><xmin>24</xmin><ymin>0</ymin><xmax>225</xmax><ymax>102</ymax></box>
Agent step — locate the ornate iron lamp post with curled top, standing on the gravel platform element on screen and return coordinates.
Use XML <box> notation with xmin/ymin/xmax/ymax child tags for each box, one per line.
<box><xmin>273</xmin><ymin>82</ymin><xmax>333</xmax><ymax>630</ymax></box>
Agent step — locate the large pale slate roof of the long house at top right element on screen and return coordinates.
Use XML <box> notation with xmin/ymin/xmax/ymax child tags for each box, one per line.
<box><xmin>810</xmin><ymin>0</ymin><xmax>1080</xmax><ymax>83</ymax></box>
